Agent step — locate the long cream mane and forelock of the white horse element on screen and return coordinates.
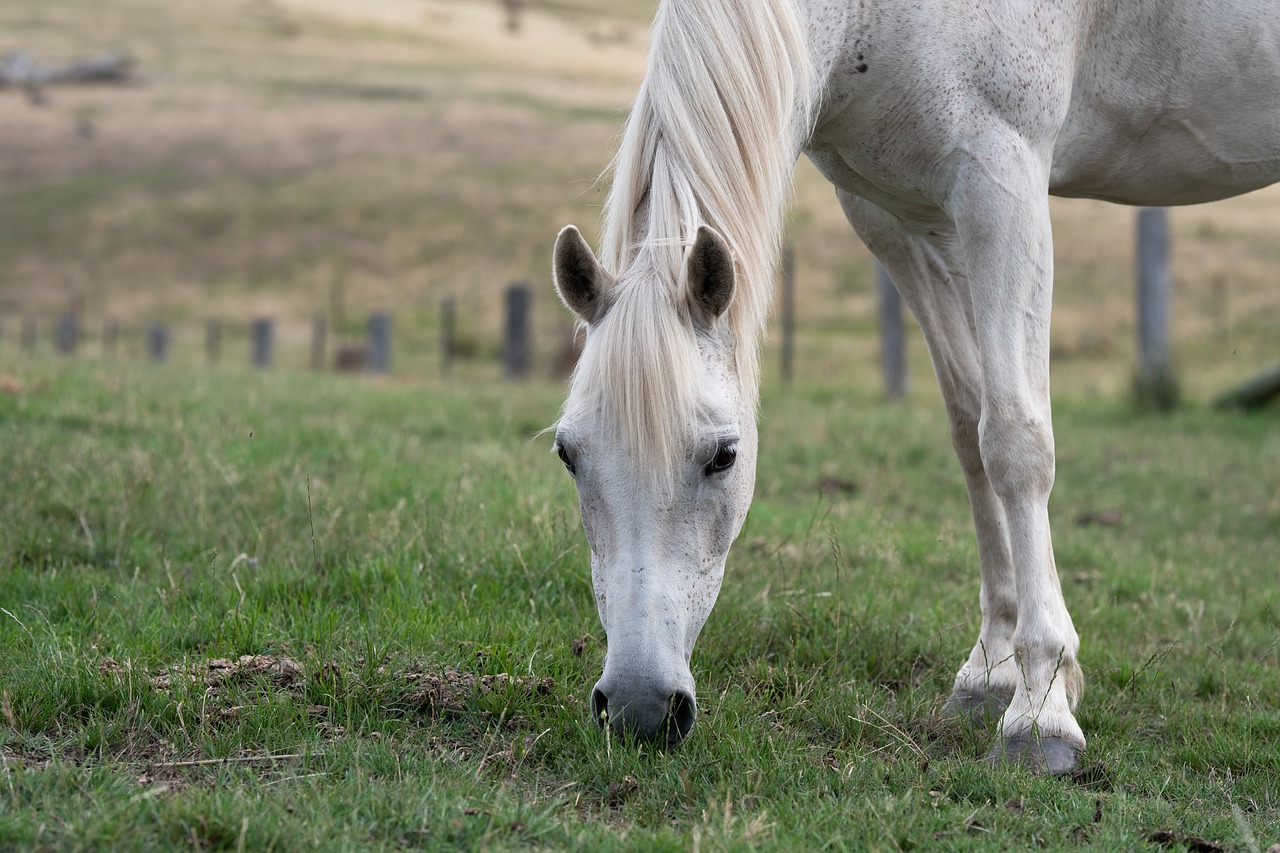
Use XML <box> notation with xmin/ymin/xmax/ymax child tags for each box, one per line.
<box><xmin>575</xmin><ymin>0</ymin><xmax>814</xmax><ymax>469</ymax></box>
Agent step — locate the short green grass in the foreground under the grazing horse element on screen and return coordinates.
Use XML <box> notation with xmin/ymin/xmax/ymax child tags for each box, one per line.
<box><xmin>0</xmin><ymin>362</ymin><xmax>1280</xmax><ymax>849</ymax></box>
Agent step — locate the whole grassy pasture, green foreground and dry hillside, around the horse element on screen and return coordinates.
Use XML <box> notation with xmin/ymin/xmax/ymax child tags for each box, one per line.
<box><xmin>0</xmin><ymin>0</ymin><xmax>1280</xmax><ymax>850</ymax></box>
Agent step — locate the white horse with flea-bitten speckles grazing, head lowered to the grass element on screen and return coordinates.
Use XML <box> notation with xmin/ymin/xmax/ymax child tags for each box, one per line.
<box><xmin>554</xmin><ymin>0</ymin><xmax>1280</xmax><ymax>774</ymax></box>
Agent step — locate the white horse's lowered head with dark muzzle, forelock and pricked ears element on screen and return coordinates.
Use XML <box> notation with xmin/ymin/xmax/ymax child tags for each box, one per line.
<box><xmin>554</xmin><ymin>225</ymin><xmax>756</xmax><ymax>744</ymax></box>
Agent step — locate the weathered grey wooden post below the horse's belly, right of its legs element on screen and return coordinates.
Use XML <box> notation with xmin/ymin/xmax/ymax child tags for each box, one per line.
<box><xmin>1134</xmin><ymin>207</ymin><xmax>1178</xmax><ymax>411</ymax></box>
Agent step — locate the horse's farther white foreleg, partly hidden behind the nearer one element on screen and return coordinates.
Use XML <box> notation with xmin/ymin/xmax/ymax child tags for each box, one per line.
<box><xmin>837</xmin><ymin>191</ymin><xmax>1019</xmax><ymax>720</ymax></box>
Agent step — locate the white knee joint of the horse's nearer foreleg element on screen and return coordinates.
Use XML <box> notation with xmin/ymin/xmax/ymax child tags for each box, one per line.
<box><xmin>978</xmin><ymin>407</ymin><xmax>1055</xmax><ymax>500</ymax></box>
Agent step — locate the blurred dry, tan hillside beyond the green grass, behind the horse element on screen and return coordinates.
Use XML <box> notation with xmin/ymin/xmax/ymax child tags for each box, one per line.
<box><xmin>0</xmin><ymin>0</ymin><xmax>1280</xmax><ymax>401</ymax></box>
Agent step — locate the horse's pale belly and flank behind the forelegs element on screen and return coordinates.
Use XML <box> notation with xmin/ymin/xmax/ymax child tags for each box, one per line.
<box><xmin>1050</xmin><ymin>0</ymin><xmax>1280</xmax><ymax>205</ymax></box>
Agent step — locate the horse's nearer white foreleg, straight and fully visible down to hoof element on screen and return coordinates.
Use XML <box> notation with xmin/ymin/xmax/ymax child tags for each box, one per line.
<box><xmin>948</xmin><ymin>140</ymin><xmax>1084</xmax><ymax>774</ymax></box>
